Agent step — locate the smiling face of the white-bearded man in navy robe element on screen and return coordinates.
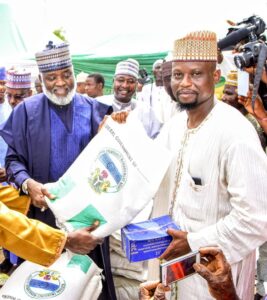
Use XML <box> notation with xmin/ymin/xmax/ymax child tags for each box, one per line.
<box><xmin>41</xmin><ymin>67</ymin><xmax>76</xmax><ymax>106</ymax></box>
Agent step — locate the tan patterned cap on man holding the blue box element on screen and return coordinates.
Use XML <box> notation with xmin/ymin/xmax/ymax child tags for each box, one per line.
<box><xmin>173</xmin><ymin>31</ymin><xmax>217</xmax><ymax>61</ymax></box>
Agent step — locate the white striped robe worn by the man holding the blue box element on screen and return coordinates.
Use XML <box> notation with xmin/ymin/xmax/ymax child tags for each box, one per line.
<box><xmin>153</xmin><ymin>102</ymin><xmax>267</xmax><ymax>300</ymax></box>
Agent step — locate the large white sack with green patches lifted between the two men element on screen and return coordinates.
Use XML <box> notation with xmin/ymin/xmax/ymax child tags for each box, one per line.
<box><xmin>46</xmin><ymin>115</ymin><xmax>170</xmax><ymax>237</ymax></box>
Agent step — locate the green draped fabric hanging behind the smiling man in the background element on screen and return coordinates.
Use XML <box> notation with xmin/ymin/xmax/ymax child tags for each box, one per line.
<box><xmin>72</xmin><ymin>52</ymin><xmax>167</xmax><ymax>94</ymax></box>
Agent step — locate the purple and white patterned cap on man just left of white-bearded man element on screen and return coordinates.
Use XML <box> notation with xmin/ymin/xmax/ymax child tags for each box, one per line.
<box><xmin>6</xmin><ymin>69</ymin><xmax>31</xmax><ymax>89</ymax></box>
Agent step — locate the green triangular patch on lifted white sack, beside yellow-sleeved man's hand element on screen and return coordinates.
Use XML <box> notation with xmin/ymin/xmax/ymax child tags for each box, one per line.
<box><xmin>67</xmin><ymin>204</ymin><xmax>107</xmax><ymax>229</ymax></box>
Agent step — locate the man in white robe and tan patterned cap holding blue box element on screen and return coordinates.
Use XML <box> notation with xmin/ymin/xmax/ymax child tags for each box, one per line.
<box><xmin>151</xmin><ymin>31</ymin><xmax>267</xmax><ymax>300</ymax></box>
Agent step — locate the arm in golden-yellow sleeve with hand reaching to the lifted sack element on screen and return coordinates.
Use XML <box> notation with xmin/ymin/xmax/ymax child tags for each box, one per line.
<box><xmin>0</xmin><ymin>202</ymin><xmax>103</xmax><ymax>266</ymax></box>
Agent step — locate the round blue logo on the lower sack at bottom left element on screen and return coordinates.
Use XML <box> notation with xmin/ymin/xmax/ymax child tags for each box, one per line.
<box><xmin>24</xmin><ymin>269</ymin><xmax>66</xmax><ymax>299</ymax></box>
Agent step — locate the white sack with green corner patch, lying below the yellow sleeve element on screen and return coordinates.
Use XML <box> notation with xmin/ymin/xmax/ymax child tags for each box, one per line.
<box><xmin>0</xmin><ymin>252</ymin><xmax>102</xmax><ymax>300</ymax></box>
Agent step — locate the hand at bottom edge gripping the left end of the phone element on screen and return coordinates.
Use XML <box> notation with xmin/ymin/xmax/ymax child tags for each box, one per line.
<box><xmin>139</xmin><ymin>281</ymin><xmax>170</xmax><ymax>300</ymax></box>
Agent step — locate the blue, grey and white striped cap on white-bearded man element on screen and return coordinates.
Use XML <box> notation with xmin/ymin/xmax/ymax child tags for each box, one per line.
<box><xmin>35</xmin><ymin>41</ymin><xmax>72</xmax><ymax>73</ymax></box>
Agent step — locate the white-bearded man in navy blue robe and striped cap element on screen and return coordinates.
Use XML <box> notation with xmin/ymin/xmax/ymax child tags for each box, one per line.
<box><xmin>0</xmin><ymin>42</ymin><xmax>115</xmax><ymax>299</ymax></box>
